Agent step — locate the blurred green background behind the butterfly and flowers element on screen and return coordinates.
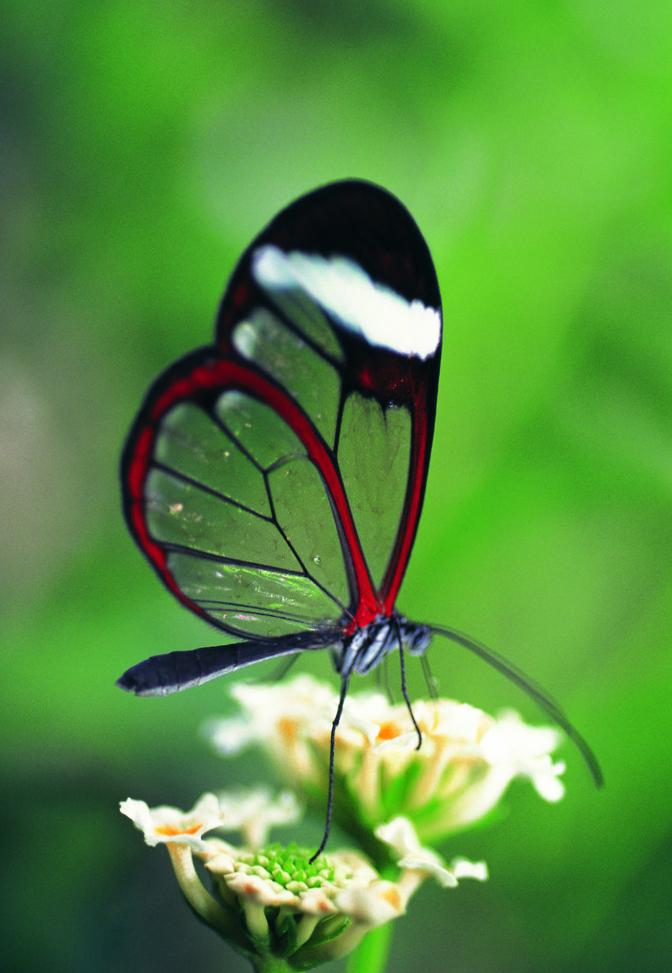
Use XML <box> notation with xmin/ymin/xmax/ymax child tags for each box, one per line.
<box><xmin>0</xmin><ymin>0</ymin><xmax>672</xmax><ymax>973</ymax></box>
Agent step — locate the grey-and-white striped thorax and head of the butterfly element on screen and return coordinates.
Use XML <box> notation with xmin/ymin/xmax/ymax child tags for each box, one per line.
<box><xmin>334</xmin><ymin>615</ymin><xmax>431</xmax><ymax>675</ymax></box>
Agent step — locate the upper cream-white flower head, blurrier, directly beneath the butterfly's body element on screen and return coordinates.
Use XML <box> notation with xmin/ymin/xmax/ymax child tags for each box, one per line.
<box><xmin>207</xmin><ymin>676</ymin><xmax>564</xmax><ymax>850</ymax></box>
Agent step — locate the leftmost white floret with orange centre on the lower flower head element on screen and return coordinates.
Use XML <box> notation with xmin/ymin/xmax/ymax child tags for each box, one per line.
<box><xmin>119</xmin><ymin>794</ymin><xmax>221</xmax><ymax>848</ymax></box>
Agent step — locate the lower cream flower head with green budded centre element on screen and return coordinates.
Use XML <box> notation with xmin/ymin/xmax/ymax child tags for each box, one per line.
<box><xmin>120</xmin><ymin>789</ymin><xmax>487</xmax><ymax>969</ymax></box>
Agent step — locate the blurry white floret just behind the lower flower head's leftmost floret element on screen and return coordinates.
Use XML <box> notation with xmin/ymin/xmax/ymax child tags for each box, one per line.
<box><xmin>219</xmin><ymin>787</ymin><xmax>301</xmax><ymax>848</ymax></box>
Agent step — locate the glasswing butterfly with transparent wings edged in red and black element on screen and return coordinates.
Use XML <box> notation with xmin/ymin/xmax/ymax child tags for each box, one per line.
<box><xmin>118</xmin><ymin>180</ymin><xmax>601</xmax><ymax>841</ymax></box>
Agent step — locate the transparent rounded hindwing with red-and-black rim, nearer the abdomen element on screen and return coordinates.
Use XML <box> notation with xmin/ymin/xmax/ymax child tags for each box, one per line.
<box><xmin>123</xmin><ymin>349</ymin><xmax>351</xmax><ymax>637</ymax></box>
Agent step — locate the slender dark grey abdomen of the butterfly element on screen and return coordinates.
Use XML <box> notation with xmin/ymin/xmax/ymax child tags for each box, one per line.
<box><xmin>117</xmin><ymin>629</ymin><xmax>343</xmax><ymax>696</ymax></box>
